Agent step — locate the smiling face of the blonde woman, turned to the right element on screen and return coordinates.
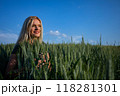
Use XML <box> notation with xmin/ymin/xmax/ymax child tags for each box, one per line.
<box><xmin>30</xmin><ymin>19</ymin><xmax>42</xmax><ymax>39</ymax></box>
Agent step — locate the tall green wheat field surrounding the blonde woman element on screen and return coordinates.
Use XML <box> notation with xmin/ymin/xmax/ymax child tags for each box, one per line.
<box><xmin>0</xmin><ymin>39</ymin><xmax>120</xmax><ymax>80</ymax></box>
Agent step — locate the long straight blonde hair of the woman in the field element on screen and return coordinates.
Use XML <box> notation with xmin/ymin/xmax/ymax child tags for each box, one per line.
<box><xmin>16</xmin><ymin>16</ymin><xmax>43</xmax><ymax>44</ymax></box>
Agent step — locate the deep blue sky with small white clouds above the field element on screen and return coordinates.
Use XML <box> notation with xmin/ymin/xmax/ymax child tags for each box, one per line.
<box><xmin>0</xmin><ymin>0</ymin><xmax>120</xmax><ymax>45</ymax></box>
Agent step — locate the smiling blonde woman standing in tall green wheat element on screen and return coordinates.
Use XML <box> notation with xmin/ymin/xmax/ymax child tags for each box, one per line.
<box><xmin>6</xmin><ymin>16</ymin><xmax>51</xmax><ymax>79</ymax></box>
